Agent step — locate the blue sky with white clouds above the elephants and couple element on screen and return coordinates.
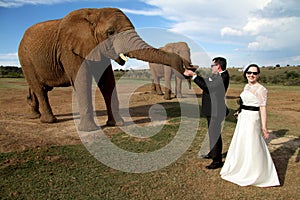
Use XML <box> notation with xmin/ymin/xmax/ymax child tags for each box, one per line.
<box><xmin>0</xmin><ymin>0</ymin><xmax>300</xmax><ymax>67</ymax></box>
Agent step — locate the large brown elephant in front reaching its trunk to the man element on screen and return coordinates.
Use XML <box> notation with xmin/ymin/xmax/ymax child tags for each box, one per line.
<box><xmin>18</xmin><ymin>8</ymin><xmax>189</xmax><ymax>131</ymax></box>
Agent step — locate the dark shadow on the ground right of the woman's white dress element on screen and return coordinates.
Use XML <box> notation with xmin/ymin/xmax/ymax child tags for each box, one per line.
<box><xmin>271</xmin><ymin>129</ymin><xmax>300</xmax><ymax>186</ymax></box>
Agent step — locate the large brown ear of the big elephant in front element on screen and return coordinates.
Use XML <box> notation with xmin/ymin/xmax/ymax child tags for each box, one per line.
<box><xmin>58</xmin><ymin>9</ymin><xmax>97</xmax><ymax>58</ymax></box>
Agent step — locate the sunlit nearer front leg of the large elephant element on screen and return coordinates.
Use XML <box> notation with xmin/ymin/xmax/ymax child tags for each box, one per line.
<box><xmin>74</xmin><ymin>62</ymin><xmax>99</xmax><ymax>131</ymax></box>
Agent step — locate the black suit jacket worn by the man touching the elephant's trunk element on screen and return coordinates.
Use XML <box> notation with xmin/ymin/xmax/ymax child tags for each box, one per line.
<box><xmin>194</xmin><ymin>70</ymin><xmax>229</xmax><ymax>119</ymax></box>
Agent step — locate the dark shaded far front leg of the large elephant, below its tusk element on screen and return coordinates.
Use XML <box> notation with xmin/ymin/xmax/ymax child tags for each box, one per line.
<box><xmin>95</xmin><ymin>64</ymin><xmax>124</xmax><ymax>126</ymax></box>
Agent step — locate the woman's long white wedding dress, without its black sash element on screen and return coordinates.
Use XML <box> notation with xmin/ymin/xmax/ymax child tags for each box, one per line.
<box><xmin>220</xmin><ymin>83</ymin><xmax>280</xmax><ymax>187</ymax></box>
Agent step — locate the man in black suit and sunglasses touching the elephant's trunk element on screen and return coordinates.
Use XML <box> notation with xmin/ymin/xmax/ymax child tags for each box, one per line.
<box><xmin>184</xmin><ymin>57</ymin><xmax>229</xmax><ymax>169</ymax></box>
